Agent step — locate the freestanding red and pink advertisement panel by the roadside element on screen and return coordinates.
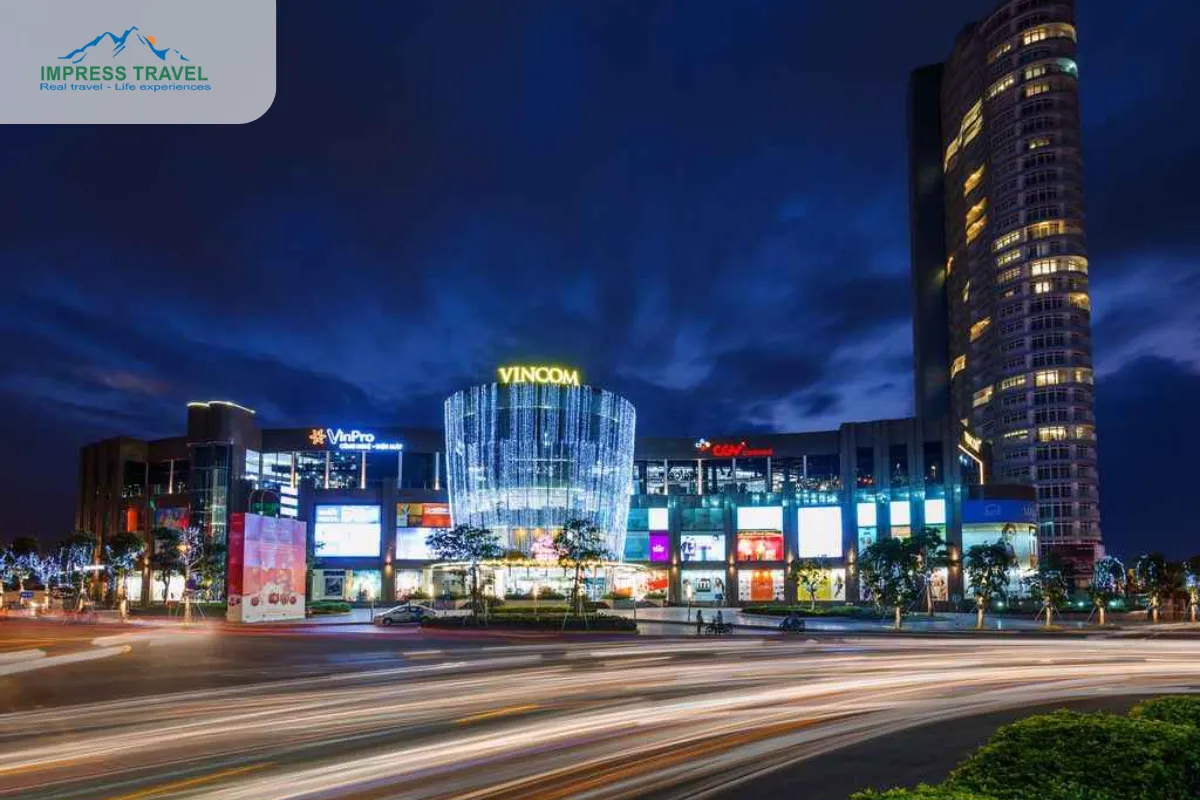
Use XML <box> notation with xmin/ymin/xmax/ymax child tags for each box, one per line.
<box><xmin>226</xmin><ymin>513</ymin><xmax>307</xmax><ymax>622</ymax></box>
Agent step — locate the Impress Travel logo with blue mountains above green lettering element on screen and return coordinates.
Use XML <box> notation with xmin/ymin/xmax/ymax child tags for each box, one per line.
<box><xmin>38</xmin><ymin>26</ymin><xmax>212</xmax><ymax>94</ymax></box>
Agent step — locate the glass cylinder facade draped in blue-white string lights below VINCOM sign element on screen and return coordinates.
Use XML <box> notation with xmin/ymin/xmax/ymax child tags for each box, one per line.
<box><xmin>445</xmin><ymin>383</ymin><xmax>636</xmax><ymax>554</ymax></box>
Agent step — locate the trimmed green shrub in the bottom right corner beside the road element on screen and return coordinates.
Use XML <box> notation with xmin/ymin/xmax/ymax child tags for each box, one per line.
<box><xmin>944</xmin><ymin>711</ymin><xmax>1200</xmax><ymax>800</ymax></box>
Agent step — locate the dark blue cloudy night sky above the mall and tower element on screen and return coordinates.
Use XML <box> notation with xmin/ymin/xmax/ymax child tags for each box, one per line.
<box><xmin>0</xmin><ymin>0</ymin><xmax>1200</xmax><ymax>557</ymax></box>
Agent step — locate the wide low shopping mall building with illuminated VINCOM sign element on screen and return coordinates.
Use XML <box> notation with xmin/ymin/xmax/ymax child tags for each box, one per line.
<box><xmin>77</xmin><ymin>367</ymin><xmax>1037</xmax><ymax>604</ymax></box>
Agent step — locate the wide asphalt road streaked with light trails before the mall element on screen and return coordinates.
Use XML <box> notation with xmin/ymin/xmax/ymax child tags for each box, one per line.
<box><xmin>0</xmin><ymin>621</ymin><xmax>1200</xmax><ymax>800</ymax></box>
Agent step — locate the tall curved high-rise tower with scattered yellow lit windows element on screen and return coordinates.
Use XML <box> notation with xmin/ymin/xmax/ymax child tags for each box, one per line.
<box><xmin>908</xmin><ymin>0</ymin><xmax>1100</xmax><ymax>573</ymax></box>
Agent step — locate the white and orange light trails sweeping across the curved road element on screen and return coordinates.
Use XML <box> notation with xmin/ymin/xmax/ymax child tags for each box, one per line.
<box><xmin>0</xmin><ymin>637</ymin><xmax>1200</xmax><ymax>800</ymax></box>
